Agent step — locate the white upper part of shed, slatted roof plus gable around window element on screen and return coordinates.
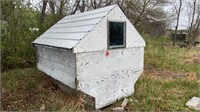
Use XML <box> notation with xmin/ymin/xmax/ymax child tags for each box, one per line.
<box><xmin>33</xmin><ymin>5</ymin><xmax>145</xmax><ymax>50</ymax></box>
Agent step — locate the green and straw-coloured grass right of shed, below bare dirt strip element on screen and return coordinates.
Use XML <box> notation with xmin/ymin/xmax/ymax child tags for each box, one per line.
<box><xmin>130</xmin><ymin>75</ymin><xmax>200</xmax><ymax>111</ymax></box>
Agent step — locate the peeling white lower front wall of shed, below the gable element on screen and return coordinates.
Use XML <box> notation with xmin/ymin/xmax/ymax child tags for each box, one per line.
<box><xmin>76</xmin><ymin>47</ymin><xmax>144</xmax><ymax>109</ymax></box>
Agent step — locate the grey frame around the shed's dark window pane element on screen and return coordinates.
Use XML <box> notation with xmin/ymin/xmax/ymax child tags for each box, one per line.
<box><xmin>107</xmin><ymin>20</ymin><xmax>126</xmax><ymax>49</ymax></box>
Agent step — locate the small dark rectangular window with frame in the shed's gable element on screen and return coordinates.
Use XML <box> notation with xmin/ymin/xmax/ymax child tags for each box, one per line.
<box><xmin>108</xmin><ymin>21</ymin><xmax>126</xmax><ymax>49</ymax></box>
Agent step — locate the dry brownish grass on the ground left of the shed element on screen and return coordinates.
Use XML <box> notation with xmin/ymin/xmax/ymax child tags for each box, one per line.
<box><xmin>1</xmin><ymin>68</ymin><xmax>77</xmax><ymax>111</ymax></box>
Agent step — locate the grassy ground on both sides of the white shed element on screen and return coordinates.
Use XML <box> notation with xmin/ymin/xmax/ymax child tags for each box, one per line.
<box><xmin>1</xmin><ymin>37</ymin><xmax>200</xmax><ymax>111</ymax></box>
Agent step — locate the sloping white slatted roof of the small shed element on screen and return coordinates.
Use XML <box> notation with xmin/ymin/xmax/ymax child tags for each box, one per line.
<box><xmin>33</xmin><ymin>5</ymin><xmax>116</xmax><ymax>49</ymax></box>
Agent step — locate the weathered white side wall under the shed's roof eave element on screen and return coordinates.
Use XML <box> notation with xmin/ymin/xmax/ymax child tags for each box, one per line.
<box><xmin>36</xmin><ymin>46</ymin><xmax>76</xmax><ymax>88</ymax></box>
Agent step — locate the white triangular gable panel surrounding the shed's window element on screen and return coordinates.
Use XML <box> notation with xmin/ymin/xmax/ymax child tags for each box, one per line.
<box><xmin>74</xmin><ymin>6</ymin><xmax>145</xmax><ymax>53</ymax></box>
